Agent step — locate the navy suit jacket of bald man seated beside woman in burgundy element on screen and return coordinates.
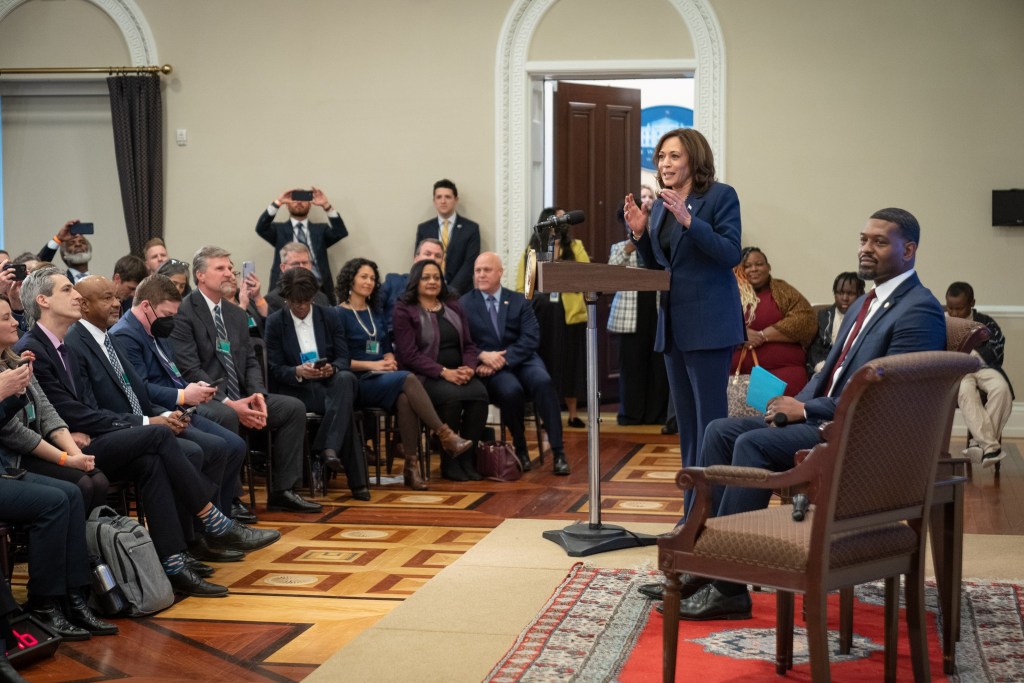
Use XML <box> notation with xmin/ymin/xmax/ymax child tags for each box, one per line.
<box><xmin>459</xmin><ymin>287</ymin><xmax>541</xmax><ymax>368</ymax></box>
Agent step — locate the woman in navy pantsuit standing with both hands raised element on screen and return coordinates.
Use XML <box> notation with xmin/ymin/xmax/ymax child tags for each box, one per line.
<box><xmin>626</xmin><ymin>128</ymin><xmax>744</xmax><ymax>467</ymax></box>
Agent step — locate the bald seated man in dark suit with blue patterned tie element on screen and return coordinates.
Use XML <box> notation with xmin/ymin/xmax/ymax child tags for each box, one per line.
<box><xmin>71</xmin><ymin>275</ymin><xmax>246</xmax><ymax>528</ymax></box>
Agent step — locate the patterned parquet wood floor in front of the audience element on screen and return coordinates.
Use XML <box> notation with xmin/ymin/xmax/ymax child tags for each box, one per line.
<box><xmin>6</xmin><ymin>416</ymin><xmax>1024</xmax><ymax>682</ymax></box>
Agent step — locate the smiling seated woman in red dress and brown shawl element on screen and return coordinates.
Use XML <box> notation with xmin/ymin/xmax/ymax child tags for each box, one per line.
<box><xmin>729</xmin><ymin>247</ymin><xmax>817</xmax><ymax>396</ymax></box>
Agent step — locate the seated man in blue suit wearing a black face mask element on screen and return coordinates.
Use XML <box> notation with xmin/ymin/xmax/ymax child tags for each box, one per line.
<box><xmin>109</xmin><ymin>274</ymin><xmax>256</xmax><ymax>524</ymax></box>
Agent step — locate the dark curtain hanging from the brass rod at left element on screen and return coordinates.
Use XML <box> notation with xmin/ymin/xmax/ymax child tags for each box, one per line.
<box><xmin>106</xmin><ymin>75</ymin><xmax>164</xmax><ymax>255</ymax></box>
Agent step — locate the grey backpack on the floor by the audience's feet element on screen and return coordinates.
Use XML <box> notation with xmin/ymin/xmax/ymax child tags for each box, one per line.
<box><xmin>85</xmin><ymin>505</ymin><xmax>174</xmax><ymax>616</ymax></box>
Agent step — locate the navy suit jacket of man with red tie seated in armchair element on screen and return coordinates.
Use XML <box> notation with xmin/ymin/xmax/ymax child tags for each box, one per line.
<box><xmin>796</xmin><ymin>273</ymin><xmax>946</xmax><ymax>422</ymax></box>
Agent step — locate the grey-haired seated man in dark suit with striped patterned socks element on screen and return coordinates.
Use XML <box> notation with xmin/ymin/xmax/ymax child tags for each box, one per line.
<box><xmin>16</xmin><ymin>266</ymin><xmax>280</xmax><ymax>597</ymax></box>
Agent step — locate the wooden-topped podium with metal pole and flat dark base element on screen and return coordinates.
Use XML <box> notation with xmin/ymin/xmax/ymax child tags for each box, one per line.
<box><xmin>537</xmin><ymin>261</ymin><xmax>669</xmax><ymax>557</ymax></box>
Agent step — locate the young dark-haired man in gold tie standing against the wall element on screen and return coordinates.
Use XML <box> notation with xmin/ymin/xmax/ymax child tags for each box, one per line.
<box><xmin>416</xmin><ymin>178</ymin><xmax>480</xmax><ymax>294</ymax></box>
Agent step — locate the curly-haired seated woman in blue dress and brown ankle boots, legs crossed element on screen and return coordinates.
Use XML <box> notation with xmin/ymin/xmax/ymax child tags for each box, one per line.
<box><xmin>337</xmin><ymin>258</ymin><xmax>473</xmax><ymax>490</ymax></box>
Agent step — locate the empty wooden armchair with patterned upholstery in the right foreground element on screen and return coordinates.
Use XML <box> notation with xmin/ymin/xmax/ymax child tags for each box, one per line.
<box><xmin>658</xmin><ymin>351</ymin><xmax>979</xmax><ymax>681</ymax></box>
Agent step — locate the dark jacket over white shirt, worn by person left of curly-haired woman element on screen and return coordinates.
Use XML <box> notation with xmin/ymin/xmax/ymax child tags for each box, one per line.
<box><xmin>266</xmin><ymin>304</ymin><xmax>349</xmax><ymax>390</ymax></box>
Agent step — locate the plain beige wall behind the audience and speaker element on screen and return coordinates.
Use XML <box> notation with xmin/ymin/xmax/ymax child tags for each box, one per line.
<box><xmin>0</xmin><ymin>0</ymin><xmax>1024</xmax><ymax>387</ymax></box>
